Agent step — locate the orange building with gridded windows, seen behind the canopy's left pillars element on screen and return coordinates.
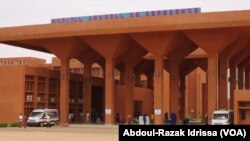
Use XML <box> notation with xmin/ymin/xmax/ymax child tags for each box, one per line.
<box><xmin>0</xmin><ymin>57</ymin><xmax>152</xmax><ymax>123</ymax></box>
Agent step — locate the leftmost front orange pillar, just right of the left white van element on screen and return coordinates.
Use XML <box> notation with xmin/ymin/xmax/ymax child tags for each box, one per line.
<box><xmin>60</xmin><ymin>59</ymin><xmax>69</xmax><ymax>126</ymax></box>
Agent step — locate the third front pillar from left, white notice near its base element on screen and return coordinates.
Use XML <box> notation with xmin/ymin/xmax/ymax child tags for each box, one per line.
<box><xmin>154</xmin><ymin>56</ymin><xmax>164</xmax><ymax>124</ymax></box>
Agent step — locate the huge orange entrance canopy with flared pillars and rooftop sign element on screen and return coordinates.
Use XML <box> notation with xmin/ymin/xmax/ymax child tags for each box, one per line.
<box><xmin>0</xmin><ymin>9</ymin><xmax>250</xmax><ymax>124</ymax></box>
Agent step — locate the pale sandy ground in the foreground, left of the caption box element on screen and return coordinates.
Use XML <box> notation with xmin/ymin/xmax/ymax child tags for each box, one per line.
<box><xmin>0</xmin><ymin>125</ymin><xmax>118</xmax><ymax>141</ymax></box>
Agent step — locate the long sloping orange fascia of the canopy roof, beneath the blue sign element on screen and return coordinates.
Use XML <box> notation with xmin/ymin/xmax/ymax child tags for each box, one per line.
<box><xmin>0</xmin><ymin>10</ymin><xmax>250</xmax><ymax>42</ymax></box>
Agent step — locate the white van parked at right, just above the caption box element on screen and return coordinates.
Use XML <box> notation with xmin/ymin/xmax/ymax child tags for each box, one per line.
<box><xmin>211</xmin><ymin>109</ymin><xmax>234</xmax><ymax>125</ymax></box>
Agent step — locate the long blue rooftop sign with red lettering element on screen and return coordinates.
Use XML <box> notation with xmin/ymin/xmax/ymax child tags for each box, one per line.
<box><xmin>51</xmin><ymin>8</ymin><xmax>201</xmax><ymax>24</ymax></box>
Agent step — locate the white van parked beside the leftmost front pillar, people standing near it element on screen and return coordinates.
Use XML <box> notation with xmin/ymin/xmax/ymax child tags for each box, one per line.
<box><xmin>27</xmin><ymin>109</ymin><xmax>59</xmax><ymax>126</ymax></box>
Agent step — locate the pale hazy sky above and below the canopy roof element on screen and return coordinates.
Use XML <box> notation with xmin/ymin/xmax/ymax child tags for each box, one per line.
<box><xmin>0</xmin><ymin>0</ymin><xmax>250</xmax><ymax>63</ymax></box>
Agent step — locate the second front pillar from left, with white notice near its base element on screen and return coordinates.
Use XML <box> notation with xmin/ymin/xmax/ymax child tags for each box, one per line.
<box><xmin>105</xmin><ymin>58</ymin><xmax>115</xmax><ymax>124</ymax></box>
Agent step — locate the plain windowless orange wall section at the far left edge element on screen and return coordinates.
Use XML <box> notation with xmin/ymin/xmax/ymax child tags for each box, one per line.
<box><xmin>0</xmin><ymin>66</ymin><xmax>24</xmax><ymax>122</ymax></box>
